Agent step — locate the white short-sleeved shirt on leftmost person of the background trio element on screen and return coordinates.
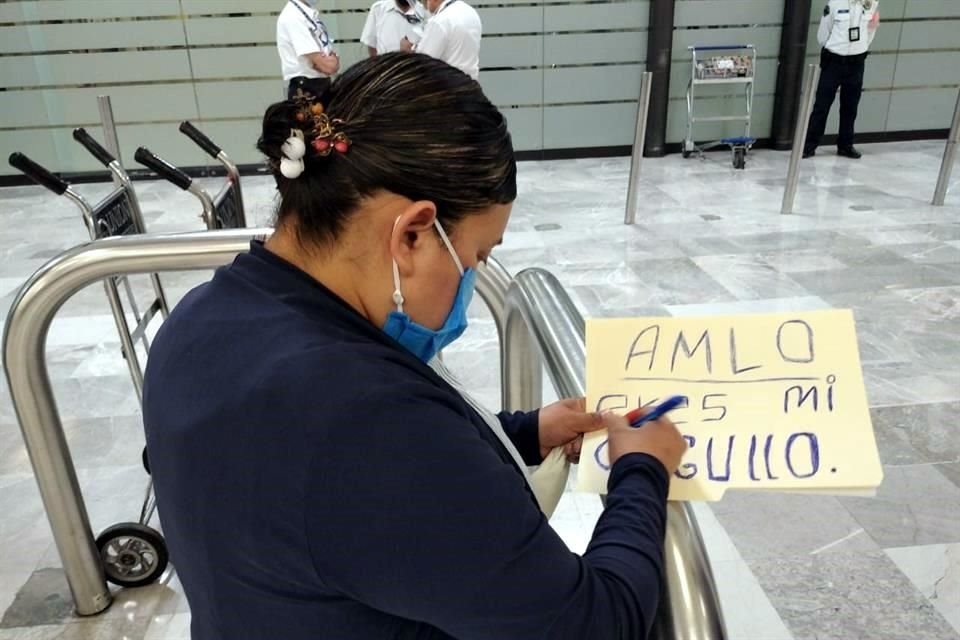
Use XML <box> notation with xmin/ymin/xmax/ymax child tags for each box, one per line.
<box><xmin>277</xmin><ymin>0</ymin><xmax>333</xmax><ymax>81</ymax></box>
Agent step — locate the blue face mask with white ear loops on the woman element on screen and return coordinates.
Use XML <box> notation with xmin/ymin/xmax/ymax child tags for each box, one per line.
<box><xmin>383</xmin><ymin>220</ymin><xmax>477</xmax><ymax>362</ymax></box>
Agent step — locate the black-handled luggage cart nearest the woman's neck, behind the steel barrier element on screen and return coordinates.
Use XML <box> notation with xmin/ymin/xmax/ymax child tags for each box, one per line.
<box><xmin>133</xmin><ymin>121</ymin><xmax>247</xmax><ymax>231</ymax></box>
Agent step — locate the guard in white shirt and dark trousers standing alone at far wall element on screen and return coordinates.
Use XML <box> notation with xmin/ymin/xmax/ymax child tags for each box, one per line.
<box><xmin>803</xmin><ymin>0</ymin><xmax>880</xmax><ymax>160</ymax></box>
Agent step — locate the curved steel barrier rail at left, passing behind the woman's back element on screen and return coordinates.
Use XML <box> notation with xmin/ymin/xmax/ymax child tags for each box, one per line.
<box><xmin>3</xmin><ymin>229</ymin><xmax>524</xmax><ymax>615</ymax></box>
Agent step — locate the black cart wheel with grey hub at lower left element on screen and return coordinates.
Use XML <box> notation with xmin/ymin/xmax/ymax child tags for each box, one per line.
<box><xmin>97</xmin><ymin>522</ymin><xmax>170</xmax><ymax>587</ymax></box>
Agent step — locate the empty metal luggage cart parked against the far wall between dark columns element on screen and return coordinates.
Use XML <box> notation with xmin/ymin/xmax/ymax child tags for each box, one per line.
<box><xmin>683</xmin><ymin>44</ymin><xmax>757</xmax><ymax>169</ymax></box>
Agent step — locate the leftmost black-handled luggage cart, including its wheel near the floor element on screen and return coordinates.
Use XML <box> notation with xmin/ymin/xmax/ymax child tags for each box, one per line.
<box><xmin>9</xmin><ymin>128</ymin><xmax>169</xmax><ymax>587</ymax></box>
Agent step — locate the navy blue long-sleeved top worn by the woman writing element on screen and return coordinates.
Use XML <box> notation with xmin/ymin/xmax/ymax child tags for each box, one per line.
<box><xmin>144</xmin><ymin>243</ymin><xmax>667</xmax><ymax>640</ymax></box>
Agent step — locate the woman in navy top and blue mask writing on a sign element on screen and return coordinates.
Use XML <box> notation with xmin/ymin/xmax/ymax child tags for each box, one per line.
<box><xmin>144</xmin><ymin>54</ymin><xmax>684</xmax><ymax>640</ymax></box>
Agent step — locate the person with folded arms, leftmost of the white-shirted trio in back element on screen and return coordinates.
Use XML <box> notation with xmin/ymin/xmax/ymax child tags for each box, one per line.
<box><xmin>277</xmin><ymin>0</ymin><xmax>340</xmax><ymax>98</ymax></box>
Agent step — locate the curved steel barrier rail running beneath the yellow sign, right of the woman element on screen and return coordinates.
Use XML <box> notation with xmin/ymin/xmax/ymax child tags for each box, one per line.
<box><xmin>503</xmin><ymin>269</ymin><xmax>726</xmax><ymax>640</ymax></box>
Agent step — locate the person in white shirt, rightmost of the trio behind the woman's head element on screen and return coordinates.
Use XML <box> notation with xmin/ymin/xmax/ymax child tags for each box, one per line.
<box><xmin>400</xmin><ymin>0</ymin><xmax>483</xmax><ymax>80</ymax></box>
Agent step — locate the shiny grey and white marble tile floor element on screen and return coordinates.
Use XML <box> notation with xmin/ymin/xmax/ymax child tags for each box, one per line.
<box><xmin>0</xmin><ymin>142</ymin><xmax>960</xmax><ymax>640</ymax></box>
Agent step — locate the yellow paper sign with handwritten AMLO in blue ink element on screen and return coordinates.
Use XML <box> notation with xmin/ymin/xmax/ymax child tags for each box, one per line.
<box><xmin>578</xmin><ymin>310</ymin><xmax>883</xmax><ymax>500</ymax></box>
